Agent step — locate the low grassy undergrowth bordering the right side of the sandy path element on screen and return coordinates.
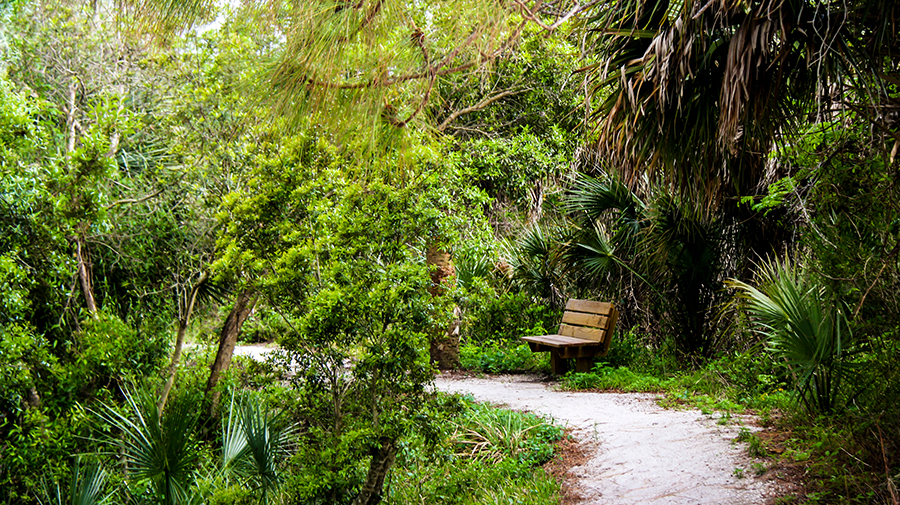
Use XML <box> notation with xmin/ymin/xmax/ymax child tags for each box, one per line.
<box><xmin>560</xmin><ymin>338</ymin><xmax>900</xmax><ymax>504</ymax></box>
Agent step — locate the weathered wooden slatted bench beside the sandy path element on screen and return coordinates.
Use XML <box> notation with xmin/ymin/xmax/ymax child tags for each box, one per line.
<box><xmin>522</xmin><ymin>299</ymin><xmax>619</xmax><ymax>375</ymax></box>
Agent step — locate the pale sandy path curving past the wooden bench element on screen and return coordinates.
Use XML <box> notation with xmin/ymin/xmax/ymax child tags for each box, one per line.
<box><xmin>435</xmin><ymin>375</ymin><xmax>777</xmax><ymax>505</ymax></box>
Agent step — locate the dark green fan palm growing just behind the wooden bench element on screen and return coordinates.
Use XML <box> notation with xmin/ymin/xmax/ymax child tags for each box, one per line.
<box><xmin>564</xmin><ymin>169</ymin><xmax>739</xmax><ymax>354</ymax></box>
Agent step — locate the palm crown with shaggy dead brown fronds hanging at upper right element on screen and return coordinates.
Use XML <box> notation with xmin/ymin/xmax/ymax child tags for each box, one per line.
<box><xmin>583</xmin><ymin>0</ymin><xmax>900</xmax><ymax>206</ymax></box>
